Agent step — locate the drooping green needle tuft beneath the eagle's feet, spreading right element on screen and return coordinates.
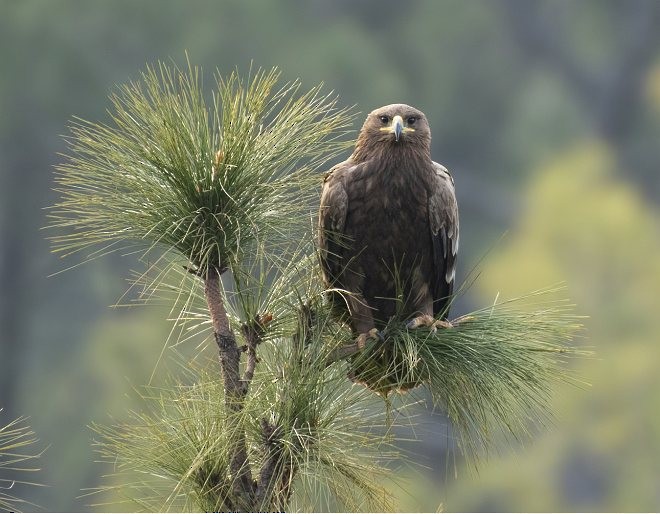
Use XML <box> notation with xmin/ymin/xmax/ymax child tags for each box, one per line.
<box><xmin>351</xmin><ymin>288</ymin><xmax>590</xmax><ymax>457</ymax></box>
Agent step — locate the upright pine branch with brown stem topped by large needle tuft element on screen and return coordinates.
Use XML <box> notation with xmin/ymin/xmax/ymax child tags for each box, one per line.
<box><xmin>50</xmin><ymin>63</ymin><xmax>352</xmax><ymax>510</ymax></box>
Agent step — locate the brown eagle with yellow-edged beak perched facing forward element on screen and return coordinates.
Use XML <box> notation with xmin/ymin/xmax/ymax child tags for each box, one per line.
<box><xmin>318</xmin><ymin>104</ymin><xmax>458</xmax><ymax>344</ymax></box>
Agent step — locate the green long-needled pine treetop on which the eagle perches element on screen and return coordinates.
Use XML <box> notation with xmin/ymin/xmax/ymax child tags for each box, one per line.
<box><xmin>50</xmin><ymin>63</ymin><xmax>579</xmax><ymax>511</ymax></box>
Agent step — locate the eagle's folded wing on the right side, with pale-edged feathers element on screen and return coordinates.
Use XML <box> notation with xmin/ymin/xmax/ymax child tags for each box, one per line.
<box><xmin>429</xmin><ymin>162</ymin><xmax>458</xmax><ymax>318</ymax></box>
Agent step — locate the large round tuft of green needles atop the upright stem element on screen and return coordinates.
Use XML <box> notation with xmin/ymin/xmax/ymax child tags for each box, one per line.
<box><xmin>50</xmin><ymin>64</ymin><xmax>352</xmax><ymax>276</ymax></box>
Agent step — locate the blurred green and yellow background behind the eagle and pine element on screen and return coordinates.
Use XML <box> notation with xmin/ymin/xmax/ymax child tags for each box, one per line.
<box><xmin>0</xmin><ymin>0</ymin><xmax>660</xmax><ymax>511</ymax></box>
